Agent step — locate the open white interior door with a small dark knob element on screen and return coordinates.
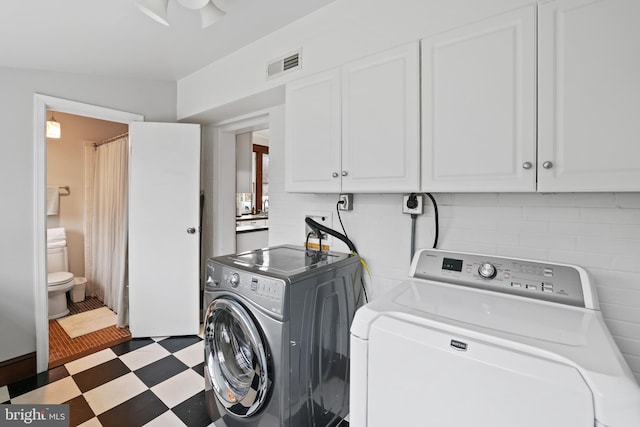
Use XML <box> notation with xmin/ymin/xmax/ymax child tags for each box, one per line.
<box><xmin>129</xmin><ymin>122</ymin><xmax>200</xmax><ymax>337</ymax></box>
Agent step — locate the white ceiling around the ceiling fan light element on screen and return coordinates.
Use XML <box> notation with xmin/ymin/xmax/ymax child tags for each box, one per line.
<box><xmin>0</xmin><ymin>0</ymin><xmax>334</xmax><ymax>81</ymax></box>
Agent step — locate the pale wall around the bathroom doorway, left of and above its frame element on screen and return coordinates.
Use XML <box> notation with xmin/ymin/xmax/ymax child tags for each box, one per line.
<box><xmin>0</xmin><ymin>68</ymin><xmax>176</xmax><ymax>361</ymax></box>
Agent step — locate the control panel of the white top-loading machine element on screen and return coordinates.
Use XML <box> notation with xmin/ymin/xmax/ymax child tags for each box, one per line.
<box><xmin>412</xmin><ymin>250</ymin><xmax>585</xmax><ymax>307</ymax></box>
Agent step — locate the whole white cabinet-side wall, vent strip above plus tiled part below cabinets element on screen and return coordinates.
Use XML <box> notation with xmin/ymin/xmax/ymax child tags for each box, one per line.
<box><xmin>178</xmin><ymin>0</ymin><xmax>640</xmax><ymax>378</ymax></box>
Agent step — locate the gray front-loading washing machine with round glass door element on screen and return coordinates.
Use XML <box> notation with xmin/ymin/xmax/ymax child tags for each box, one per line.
<box><xmin>203</xmin><ymin>245</ymin><xmax>362</xmax><ymax>427</ymax></box>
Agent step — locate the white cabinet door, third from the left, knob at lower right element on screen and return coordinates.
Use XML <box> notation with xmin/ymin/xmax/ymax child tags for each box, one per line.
<box><xmin>422</xmin><ymin>5</ymin><xmax>536</xmax><ymax>192</ymax></box>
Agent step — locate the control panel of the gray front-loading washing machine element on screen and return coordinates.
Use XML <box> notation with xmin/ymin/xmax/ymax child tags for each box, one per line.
<box><xmin>205</xmin><ymin>260</ymin><xmax>285</xmax><ymax>316</ymax></box>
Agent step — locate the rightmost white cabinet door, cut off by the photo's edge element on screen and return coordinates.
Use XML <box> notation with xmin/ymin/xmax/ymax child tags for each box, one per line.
<box><xmin>538</xmin><ymin>0</ymin><xmax>640</xmax><ymax>191</ymax></box>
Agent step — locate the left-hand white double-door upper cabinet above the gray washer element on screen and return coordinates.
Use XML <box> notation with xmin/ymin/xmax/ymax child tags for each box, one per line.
<box><xmin>285</xmin><ymin>43</ymin><xmax>420</xmax><ymax>193</ymax></box>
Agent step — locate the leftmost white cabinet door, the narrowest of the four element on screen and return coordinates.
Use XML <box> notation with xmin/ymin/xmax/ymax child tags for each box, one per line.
<box><xmin>285</xmin><ymin>68</ymin><xmax>341</xmax><ymax>193</ymax></box>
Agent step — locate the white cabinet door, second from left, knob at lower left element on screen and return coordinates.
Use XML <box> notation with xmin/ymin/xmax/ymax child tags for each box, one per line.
<box><xmin>341</xmin><ymin>42</ymin><xmax>420</xmax><ymax>192</ymax></box>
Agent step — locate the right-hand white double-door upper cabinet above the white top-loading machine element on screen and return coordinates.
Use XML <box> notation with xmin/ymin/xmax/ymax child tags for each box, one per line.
<box><xmin>422</xmin><ymin>0</ymin><xmax>640</xmax><ymax>192</ymax></box>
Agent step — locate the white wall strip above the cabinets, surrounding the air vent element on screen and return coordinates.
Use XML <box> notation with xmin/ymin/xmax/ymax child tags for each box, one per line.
<box><xmin>178</xmin><ymin>0</ymin><xmax>534</xmax><ymax>119</ymax></box>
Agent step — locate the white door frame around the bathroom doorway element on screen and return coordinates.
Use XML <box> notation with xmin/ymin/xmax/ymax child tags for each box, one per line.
<box><xmin>33</xmin><ymin>93</ymin><xmax>144</xmax><ymax>373</ymax></box>
